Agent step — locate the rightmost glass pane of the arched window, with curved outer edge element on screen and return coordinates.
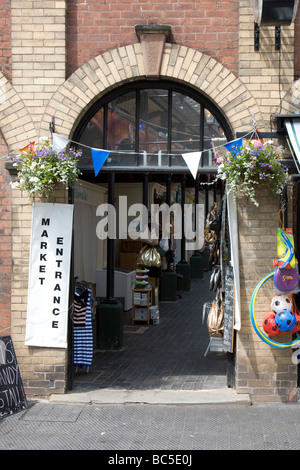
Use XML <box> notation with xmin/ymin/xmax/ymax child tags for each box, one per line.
<box><xmin>202</xmin><ymin>109</ymin><xmax>227</xmax><ymax>166</ymax></box>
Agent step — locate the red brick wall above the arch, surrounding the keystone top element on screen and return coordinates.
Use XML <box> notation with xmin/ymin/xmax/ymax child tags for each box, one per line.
<box><xmin>67</xmin><ymin>0</ymin><xmax>239</xmax><ymax>75</ymax></box>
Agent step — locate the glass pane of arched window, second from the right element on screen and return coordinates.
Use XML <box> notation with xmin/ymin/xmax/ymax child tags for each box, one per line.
<box><xmin>171</xmin><ymin>92</ymin><xmax>201</xmax><ymax>165</ymax></box>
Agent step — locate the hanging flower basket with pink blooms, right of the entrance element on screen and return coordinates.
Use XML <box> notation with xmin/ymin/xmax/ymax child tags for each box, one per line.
<box><xmin>217</xmin><ymin>140</ymin><xmax>288</xmax><ymax>206</ymax></box>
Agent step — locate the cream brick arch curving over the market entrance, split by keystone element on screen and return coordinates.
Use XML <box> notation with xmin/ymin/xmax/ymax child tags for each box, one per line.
<box><xmin>42</xmin><ymin>43</ymin><xmax>264</xmax><ymax>137</ymax></box>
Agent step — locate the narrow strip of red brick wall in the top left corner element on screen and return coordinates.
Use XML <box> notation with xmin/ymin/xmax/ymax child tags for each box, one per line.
<box><xmin>0</xmin><ymin>0</ymin><xmax>11</xmax><ymax>79</ymax></box>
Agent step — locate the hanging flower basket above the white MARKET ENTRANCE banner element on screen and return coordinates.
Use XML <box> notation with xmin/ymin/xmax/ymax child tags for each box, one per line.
<box><xmin>11</xmin><ymin>138</ymin><xmax>81</xmax><ymax>200</ymax></box>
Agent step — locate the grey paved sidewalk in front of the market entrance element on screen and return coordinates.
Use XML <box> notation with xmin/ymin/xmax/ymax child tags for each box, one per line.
<box><xmin>0</xmin><ymin>401</ymin><xmax>300</xmax><ymax>452</ymax></box>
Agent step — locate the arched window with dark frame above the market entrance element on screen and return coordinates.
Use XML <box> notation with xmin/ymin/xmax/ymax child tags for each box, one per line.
<box><xmin>74</xmin><ymin>81</ymin><xmax>232</xmax><ymax>171</ymax></box>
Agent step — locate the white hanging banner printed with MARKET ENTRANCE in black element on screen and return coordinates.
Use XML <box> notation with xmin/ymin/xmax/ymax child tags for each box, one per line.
<box><xmin>25</xmin><ymin>203</ymin><xmax>74</xmax><ymax>348</ymax></box>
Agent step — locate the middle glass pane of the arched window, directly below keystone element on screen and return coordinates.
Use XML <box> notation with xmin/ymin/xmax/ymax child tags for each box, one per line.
<box><xmin>139</xmin><ymin>89</ymin><xmax>168</xmax><ymax>165</ymax></box>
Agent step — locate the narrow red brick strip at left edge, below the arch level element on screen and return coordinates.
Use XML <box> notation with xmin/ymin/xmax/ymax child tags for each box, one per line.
<box><xmin>0</xmin><ymin>132</ymin><xmax>12</xmax><ymax>336</ymax></box>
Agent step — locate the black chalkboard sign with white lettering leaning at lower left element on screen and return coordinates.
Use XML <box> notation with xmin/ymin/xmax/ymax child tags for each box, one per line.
<box><xmin>0</xmin><ymin>336</ymin><xmax>28</xmax><ymax>418</ymax></box>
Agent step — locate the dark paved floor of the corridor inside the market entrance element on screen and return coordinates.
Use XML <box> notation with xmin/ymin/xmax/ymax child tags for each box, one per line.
<box><xmin>72</xmin><ymin>272</ymin><xmax>228</xmax><ymax>392</ymax></box>
